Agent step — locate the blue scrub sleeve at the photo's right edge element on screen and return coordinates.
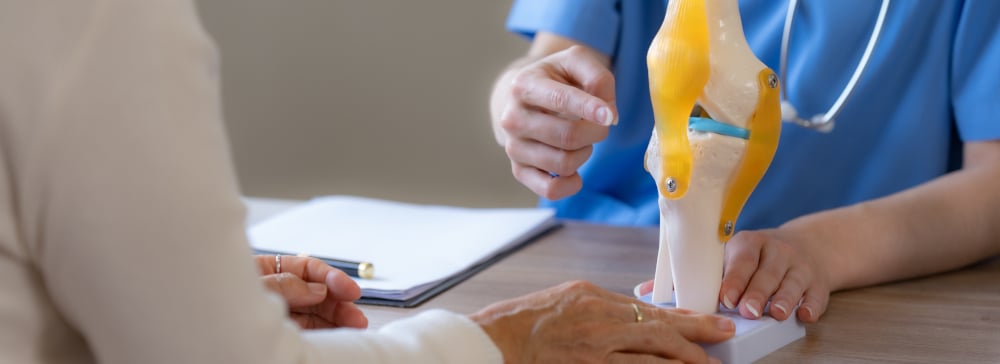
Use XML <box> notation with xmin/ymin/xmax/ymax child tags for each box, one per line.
<box><xmin>951</xmin><ymin>0</ymin><xmax>1000</xmax><ymax>142</ymax></box>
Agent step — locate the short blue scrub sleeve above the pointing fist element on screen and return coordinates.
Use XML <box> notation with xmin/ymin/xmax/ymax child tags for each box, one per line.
<box><xmin>507</xmin><ymin>0</ymin><xmax>621</xmax><ymax>57</ymax></box>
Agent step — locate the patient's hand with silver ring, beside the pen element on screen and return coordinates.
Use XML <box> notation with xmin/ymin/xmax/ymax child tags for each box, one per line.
<box><xmin>254</xmin><ymin>255</ymin><xmax>368</xmax><ymax>329</ymax></box>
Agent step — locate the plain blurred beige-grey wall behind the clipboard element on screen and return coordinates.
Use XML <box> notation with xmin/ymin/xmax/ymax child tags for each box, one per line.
<box><xmin>199</xmin><ymin>0</ymin><xmax>535</xmax><ymax>206</ymax></box>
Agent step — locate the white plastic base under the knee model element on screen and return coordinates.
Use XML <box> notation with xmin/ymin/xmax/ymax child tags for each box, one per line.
<box><xmin>639</xmin><ymin>295</ymin><xmax>806</xmax><ymax>364</ymax></box>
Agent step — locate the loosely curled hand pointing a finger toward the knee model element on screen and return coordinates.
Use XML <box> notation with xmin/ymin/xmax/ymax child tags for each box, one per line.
<box><xmin>491</xmin><ymin>35</ymin><xmax>618</xmax><ymax>200</ymax></box>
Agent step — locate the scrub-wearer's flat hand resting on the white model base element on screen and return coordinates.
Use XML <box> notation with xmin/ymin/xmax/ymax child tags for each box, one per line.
<box><xmin>634</xmin><ymin>229</ymin><xmax>831</xmax><ymax>322</ymax></box>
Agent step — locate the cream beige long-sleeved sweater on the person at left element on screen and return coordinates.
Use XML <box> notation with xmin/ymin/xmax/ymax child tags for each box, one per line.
<box><xmin>0</xmin><ymin>0</ymin><xmax>500</xmax><ymax>364</ymax></box>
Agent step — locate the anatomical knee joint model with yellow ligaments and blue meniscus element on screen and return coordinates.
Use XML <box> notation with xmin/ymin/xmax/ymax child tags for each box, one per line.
<box><xmin>645</xmin><ymin>0</ymin><xmax>781</xmax><ymax>313</ymax></box>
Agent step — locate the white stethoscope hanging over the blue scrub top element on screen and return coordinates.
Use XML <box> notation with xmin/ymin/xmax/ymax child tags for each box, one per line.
<box><xmin>780</xmin><ymin>0</ymin><xmax>889</xmax><ymax>133</ymax></box>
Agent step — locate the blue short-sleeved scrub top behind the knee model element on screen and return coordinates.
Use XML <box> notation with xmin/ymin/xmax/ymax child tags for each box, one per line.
<box><xmin>507</xmin><ymin>0</ymin><xmax>1000</xmax><ymax>229</ymax></box>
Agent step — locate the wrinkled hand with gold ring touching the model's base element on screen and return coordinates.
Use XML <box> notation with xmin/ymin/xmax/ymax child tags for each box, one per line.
<box><xmin>470</xmin><ymin>281</ymin><xmax>735</xmax><ymax>363</ymax></box>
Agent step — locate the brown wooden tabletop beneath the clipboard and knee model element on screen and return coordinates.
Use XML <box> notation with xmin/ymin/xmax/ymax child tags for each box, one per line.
<box><xmin>244</xmin><ymin>200</ymin><xmax>1000</xmax><ymax>363</ymax></box>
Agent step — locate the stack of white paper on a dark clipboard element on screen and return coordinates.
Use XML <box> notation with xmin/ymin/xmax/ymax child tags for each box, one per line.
<box><xmin>249</xmin><ymin>196</ymin><xmax>557</xmax><ymax>307</ymax></box>
